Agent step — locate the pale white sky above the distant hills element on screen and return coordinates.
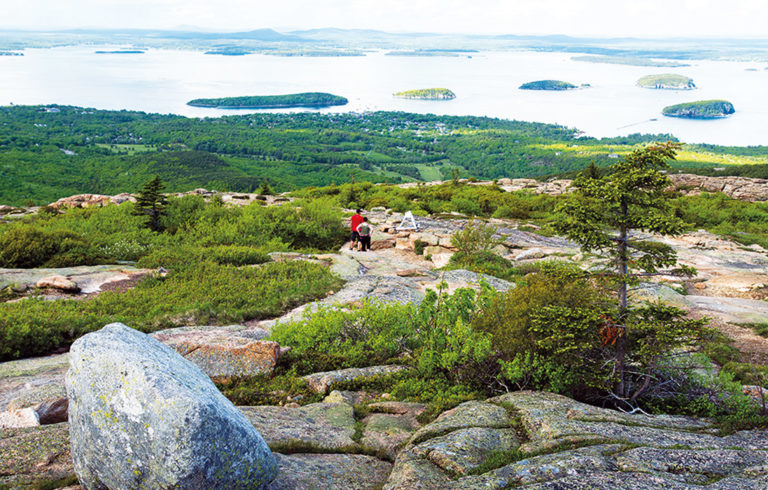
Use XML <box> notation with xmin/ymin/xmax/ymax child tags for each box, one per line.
<box><xmin>6</xmin><ymin>0</ymin><xmax>768</xmax><ymax>38</ymax></box>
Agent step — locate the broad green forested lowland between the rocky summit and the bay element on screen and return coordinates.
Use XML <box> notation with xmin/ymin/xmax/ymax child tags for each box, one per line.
<box><xmin>0</xmin><ymin>106</ymin><xmax>768</xmax><ymax>206</ymax></box>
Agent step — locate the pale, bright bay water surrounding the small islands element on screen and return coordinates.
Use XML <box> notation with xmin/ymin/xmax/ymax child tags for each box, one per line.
<box><xmin>0</xmin><ymin>46</ymin><xmax>768</xmax><ymax>146</ymax></box>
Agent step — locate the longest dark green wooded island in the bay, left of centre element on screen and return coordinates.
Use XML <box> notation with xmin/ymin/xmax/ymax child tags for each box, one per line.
<box><xmin>187</xmin><ymin>92</ymin><xmax>349</xmax><ymax>109</ymax></box>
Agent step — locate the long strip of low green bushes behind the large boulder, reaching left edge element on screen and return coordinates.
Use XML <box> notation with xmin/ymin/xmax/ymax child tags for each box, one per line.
<box><xmin>0</xmin><ymin>261</ymin><xmax>341</xmax><ymax>361</ymax></box>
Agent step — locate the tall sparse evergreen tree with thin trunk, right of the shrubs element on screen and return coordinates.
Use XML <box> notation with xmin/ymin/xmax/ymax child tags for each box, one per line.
<box><xmin>555</xmin><ymin>142</ymin><xmax>703</xmax><ymax>401</ymax></box>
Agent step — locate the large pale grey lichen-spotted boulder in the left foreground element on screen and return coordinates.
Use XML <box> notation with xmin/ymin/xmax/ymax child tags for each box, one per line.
<box><xmin>66</xmin><ymin>323</ymin><xmax>277</xmax><ymax>489</ymax></box>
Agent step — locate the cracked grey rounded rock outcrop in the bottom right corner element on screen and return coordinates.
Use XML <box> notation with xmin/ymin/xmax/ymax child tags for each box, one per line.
<box><xmin>384</xmin><ymin>391</ymin><xmax>768</xmax><ymax>490</ymax></box>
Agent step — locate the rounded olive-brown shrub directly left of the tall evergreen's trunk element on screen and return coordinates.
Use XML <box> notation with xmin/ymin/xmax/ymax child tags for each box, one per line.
<box><xmin>473</xmin><ymin>264</ymin><xmax>611</xmax><ymax>396</ymax></box>
